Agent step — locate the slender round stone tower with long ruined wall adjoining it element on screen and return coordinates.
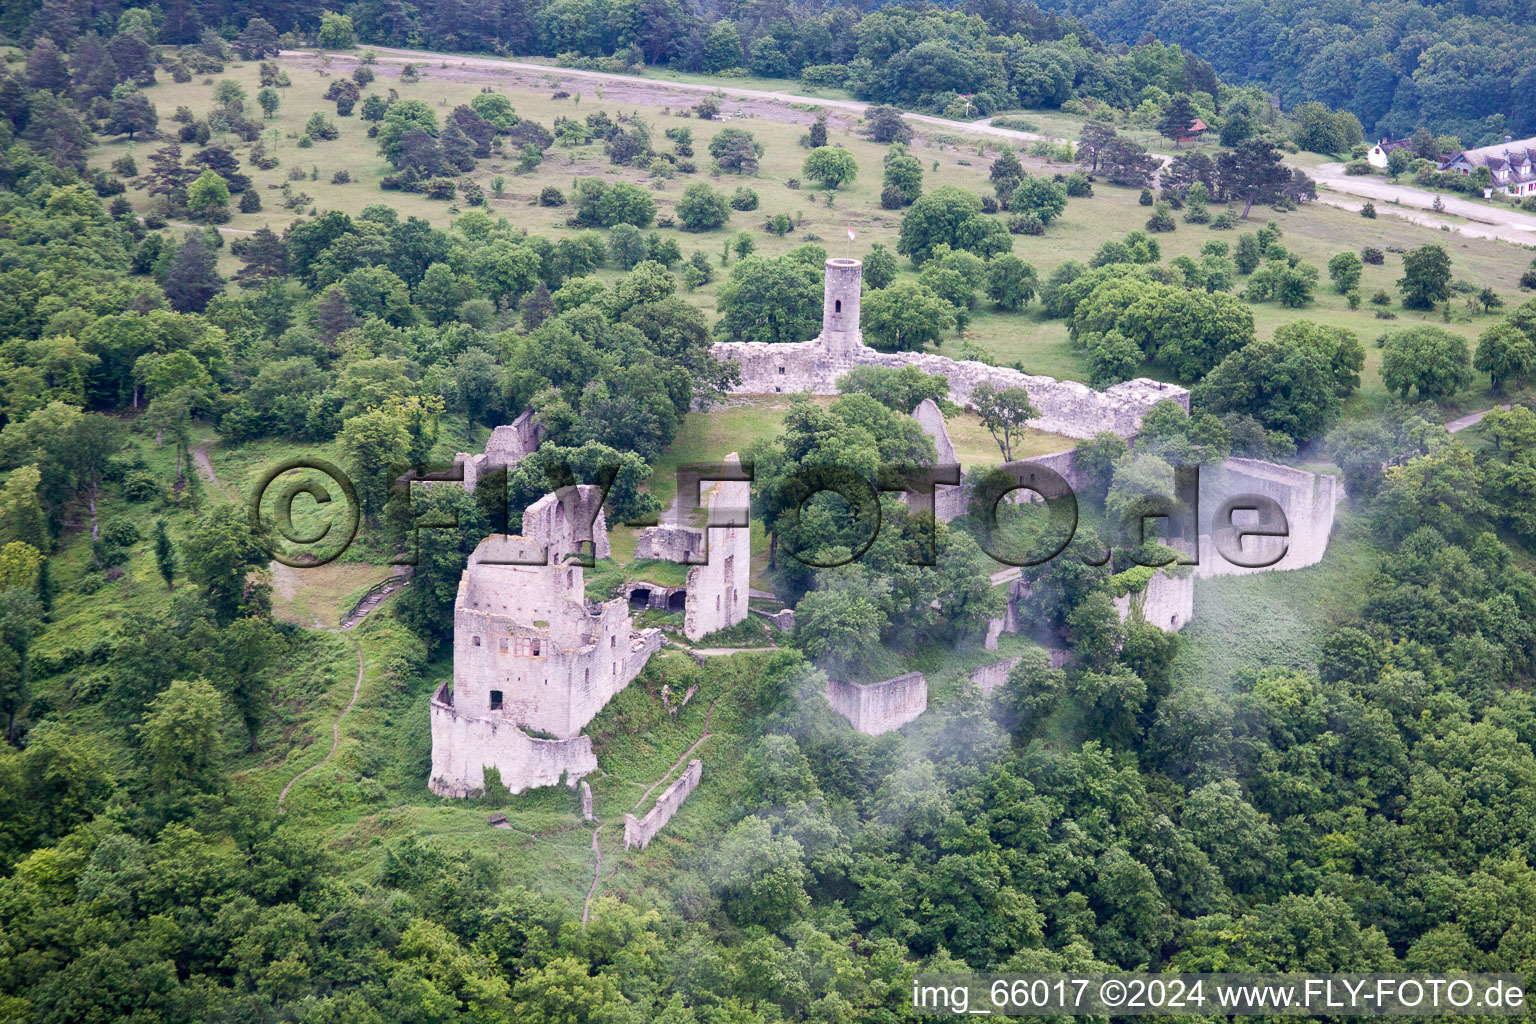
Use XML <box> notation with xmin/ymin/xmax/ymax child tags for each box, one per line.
<box><xmin>710</xmin><ymin>258</ymin><xmax>1189</xmax><ymax>438</ymax></box>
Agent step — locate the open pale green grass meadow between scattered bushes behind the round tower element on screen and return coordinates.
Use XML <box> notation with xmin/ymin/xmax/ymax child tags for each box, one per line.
<box><xmin>91</xmin><ymin>46</ymin><xmax>1528</xmax><ymax>411</ymax></box>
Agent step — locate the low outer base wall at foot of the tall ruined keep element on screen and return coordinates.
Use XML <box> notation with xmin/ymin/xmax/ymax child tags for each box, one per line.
<box><xmin>427</xmin><ymin>683</ymin><xmax>598</xmax><ymax>798</ymax></box>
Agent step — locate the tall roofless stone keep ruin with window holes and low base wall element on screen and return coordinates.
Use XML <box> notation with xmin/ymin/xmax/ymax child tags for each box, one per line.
<box><xmin>429</xmin><ymin>487</ymin><xmax>660</xmax><ymax>797</ymax></box>
